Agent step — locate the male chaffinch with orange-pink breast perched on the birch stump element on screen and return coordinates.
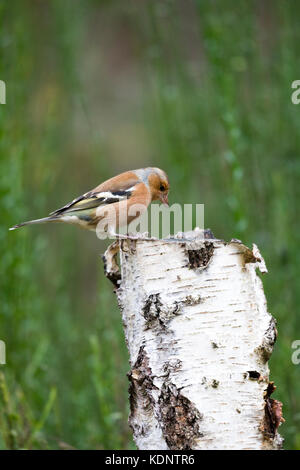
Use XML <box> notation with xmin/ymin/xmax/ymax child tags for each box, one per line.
<box><xmin>10</xmin><ymin>167</ymin><xmax>169</xmax><ymax>237</ymax></box>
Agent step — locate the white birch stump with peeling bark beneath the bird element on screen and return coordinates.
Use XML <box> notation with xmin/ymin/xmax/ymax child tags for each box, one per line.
<box><xmin>103</xmin><ymin>231</ymin><xmax>283</xmax><ymax>450</ymax></box>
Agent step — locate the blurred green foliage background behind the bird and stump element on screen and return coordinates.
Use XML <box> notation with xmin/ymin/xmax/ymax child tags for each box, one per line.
<box><xmin>0</xmin><ymin>0</ymin><xmax>300</xmax><ymax>449</ymax></box>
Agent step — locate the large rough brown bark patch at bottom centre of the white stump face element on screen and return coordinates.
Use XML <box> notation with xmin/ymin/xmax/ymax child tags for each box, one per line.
<box><xmin>158</xmin><ymin>383</ymin><xmax>203</xmax><ymax>450</ymax></box>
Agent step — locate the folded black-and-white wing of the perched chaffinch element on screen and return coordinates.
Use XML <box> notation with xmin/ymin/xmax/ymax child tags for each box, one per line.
<box><xmin>50</xmin><ymin>187</ymin><xmax>133</xmax><ymax>216</ymax></box>
